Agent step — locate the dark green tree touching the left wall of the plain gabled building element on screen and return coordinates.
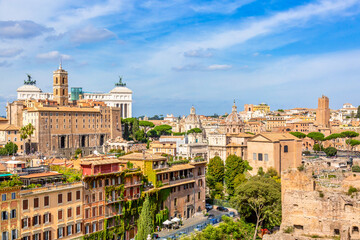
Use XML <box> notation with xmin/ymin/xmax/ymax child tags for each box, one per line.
<box><xmin>225</xmin><ymin>155</ymin><xmax>252</xmax><ymax>196</ymax></box>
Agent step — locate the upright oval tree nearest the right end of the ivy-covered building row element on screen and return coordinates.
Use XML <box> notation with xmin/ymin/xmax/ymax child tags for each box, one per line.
<box><xmin>206</xmin><ymin>156</ymin><xmax>225</xmax><ymax>198</ymax></box>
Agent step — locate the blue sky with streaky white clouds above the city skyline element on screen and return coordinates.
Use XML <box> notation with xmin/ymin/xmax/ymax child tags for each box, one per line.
<box><xmin>0</xmin><ymin>0</ymin><xmax>360</xmax><ymax>116</ymax></box>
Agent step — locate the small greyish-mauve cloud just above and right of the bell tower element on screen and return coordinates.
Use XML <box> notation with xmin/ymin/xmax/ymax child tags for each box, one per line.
<box><xmin>70</xmin><ymin>26</ymin><xmax>116</xmax><ymax>43</ymax></box>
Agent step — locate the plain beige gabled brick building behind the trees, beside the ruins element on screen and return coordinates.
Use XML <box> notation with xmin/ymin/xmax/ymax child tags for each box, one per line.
<box><xmin>247</xmin><ymin>133</ymin><xmax>302</xmax><ymax>174</ymax></box>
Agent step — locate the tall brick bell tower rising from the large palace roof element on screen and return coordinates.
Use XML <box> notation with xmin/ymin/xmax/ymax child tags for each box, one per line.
<box><xmin>53</xmin><ymin>63</ymin><xmax>69</xmax><ymax>106</ymax></box>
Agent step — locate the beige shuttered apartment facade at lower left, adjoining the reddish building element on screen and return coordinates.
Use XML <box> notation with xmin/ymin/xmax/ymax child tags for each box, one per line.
<box><xmin>19</xmin><ymin>181</ymin><xmax>83</xmax><ymax>240</ymax></box>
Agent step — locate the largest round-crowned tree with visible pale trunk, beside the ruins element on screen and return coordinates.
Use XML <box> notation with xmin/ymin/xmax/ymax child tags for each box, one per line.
<box><xmin>231</xmin><ymin>176</ymin><xmax>281</xmax><ymax>240</ymax></box>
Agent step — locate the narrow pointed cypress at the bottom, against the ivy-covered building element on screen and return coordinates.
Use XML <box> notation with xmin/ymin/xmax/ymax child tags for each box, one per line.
<box><xmin>136</xmin><ymin>196</ymin><xmax>154</xmax><ymax>240</ymax></box>
